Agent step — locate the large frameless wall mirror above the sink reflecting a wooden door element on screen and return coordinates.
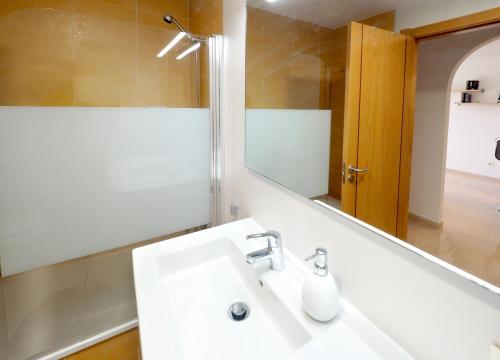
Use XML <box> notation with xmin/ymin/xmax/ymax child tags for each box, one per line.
<box><xmin>246</xmin><ymin>0</ymin><xmax>500</xmax><ymax>287</ymax></box>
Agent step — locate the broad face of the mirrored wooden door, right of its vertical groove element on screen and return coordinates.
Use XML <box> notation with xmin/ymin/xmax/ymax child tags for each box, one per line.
<box><xmin>356</xmin><ymin>25</ymin><xmax>406</xmax><ymax>235</ymax></box>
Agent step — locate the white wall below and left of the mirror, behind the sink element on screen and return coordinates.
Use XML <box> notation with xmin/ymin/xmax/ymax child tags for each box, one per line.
<box><xmin>223</xmin><ymin>0</ymin><xmax>500</xmax><ymax>360</ymax></box>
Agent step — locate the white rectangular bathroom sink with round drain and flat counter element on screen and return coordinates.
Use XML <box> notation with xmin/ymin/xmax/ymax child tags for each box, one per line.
<box><xmin>133</xmin><ymin>219</ymin><xmax>411</xmax><ymax>360</ymax></box>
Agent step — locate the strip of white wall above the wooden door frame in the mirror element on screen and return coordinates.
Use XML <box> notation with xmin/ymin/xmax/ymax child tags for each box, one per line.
<box><xmin>396</xmin><ymin>0</ymin><xmax>500</xmax><ymax>32</ymax></box>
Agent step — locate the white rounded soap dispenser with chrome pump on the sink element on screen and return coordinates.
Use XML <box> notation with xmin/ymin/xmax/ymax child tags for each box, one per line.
<box><xmin>302</xmin><ymin>248</ymin><xmax>339</xmax><ymax>321</ymax></box>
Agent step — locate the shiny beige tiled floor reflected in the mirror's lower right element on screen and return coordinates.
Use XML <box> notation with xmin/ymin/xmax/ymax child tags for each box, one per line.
<box><xmin>408</xmin><ymin>171</ymin><xmax>500</xmax><ymax>286</ymax></box>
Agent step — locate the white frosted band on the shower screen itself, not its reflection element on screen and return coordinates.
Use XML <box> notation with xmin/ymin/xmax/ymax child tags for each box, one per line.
<box><xmin>0</xmin><ymin>107</ymin><xmax>210</xmax><ymax>275</ymax></box>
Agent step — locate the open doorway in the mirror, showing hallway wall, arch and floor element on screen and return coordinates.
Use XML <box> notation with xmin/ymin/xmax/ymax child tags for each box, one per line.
<box><xmin>408</xmin><ymin>27</ymin><xmax>500</xmax><ymax>284</ymax></box>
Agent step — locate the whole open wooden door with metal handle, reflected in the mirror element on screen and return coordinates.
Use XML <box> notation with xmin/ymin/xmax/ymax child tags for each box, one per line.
<box><xmin>342</xmin><ymin>23</ymin><xmax>411</xmax><ymax>235</ymax></box>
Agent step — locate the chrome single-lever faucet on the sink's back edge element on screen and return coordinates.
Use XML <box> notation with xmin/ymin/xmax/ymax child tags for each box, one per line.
<box><xmin>246</xmin><ymin>230</ymin><xmax>285</xmax><ymax>271</ymax></box>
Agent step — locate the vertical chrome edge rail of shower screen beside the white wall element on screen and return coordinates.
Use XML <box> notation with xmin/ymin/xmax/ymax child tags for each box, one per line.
<box><xmin>208</xmin><ymin>35</ymin><xmax>223</xmax><ymax>226</ymax></box>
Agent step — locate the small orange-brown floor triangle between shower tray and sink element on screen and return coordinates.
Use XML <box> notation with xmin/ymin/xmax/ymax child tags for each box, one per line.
<box><xmin>63</xmin><ymin>329</ymin><xmax>140</xmax><ymax>360</ymax></box>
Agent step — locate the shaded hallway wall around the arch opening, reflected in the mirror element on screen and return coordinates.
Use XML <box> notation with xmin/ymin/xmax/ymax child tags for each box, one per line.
<box><xmin>410</xmin><ymin>27</ymin><xmax>500</xmax><ymax>223</ymax></box>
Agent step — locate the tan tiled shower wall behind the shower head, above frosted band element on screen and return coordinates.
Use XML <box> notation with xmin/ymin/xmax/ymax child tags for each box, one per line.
<box><xmin>0</xmin><ymin>0</ymin><xmax>222</xmax><ymax>107</ymax></box>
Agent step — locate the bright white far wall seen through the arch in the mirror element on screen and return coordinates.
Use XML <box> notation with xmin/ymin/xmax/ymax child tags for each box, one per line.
<box><xmin>446</xmin><ymin>39</ymin><xmax>500</xmax><ymax>178</ymax></box>
